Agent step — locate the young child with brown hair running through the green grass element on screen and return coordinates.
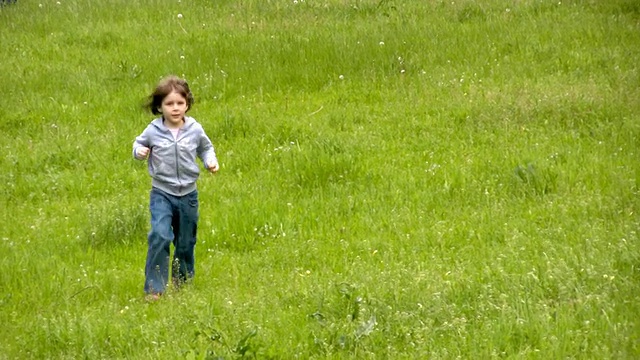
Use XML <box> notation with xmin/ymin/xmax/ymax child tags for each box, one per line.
<box><xmin>133</xmin><ymin>76</ymin><xmax>220</xmax><ymax>299</ymax></box>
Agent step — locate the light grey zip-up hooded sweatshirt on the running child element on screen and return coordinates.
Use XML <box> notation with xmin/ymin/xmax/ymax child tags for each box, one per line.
<box><xmin>133</xmin><ymin>116</ymin><xmax>218</xmax><ymax>196</ymax></box>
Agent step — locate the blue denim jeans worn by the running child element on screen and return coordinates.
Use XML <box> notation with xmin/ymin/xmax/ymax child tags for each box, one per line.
<box><xmin>144</xmin><ymin>188</ymin><xmax>198</xmax><ymax>294</ymax></box>
